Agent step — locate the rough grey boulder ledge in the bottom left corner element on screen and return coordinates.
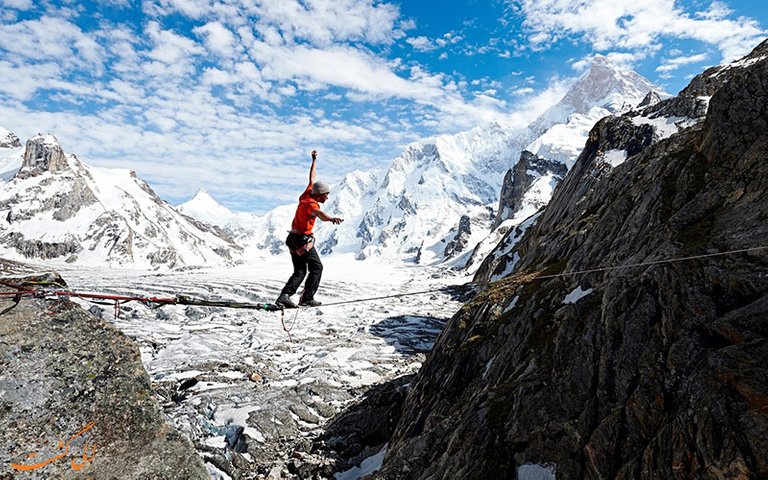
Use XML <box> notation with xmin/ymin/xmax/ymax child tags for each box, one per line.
<box><xmin>0</xmin><ymin>264</ymin><xmax>209</xmax><ymax>480</ymax></box>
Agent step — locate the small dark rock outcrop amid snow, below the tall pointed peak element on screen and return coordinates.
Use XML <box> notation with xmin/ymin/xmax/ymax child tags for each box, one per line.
<box><xmin>493</xmin><ymin>150</ymin><xmax>567</xmax><ymax>229</ymax></box>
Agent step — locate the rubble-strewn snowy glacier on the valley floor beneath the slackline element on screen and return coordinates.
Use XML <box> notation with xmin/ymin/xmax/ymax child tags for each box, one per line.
<box><xmin>61</xmin><ymin>255</ymin><xmax>469</xmax><ymax>476</ymax></box>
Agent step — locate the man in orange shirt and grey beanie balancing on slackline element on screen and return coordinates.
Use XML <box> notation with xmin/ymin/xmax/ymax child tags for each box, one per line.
<box><xmin>275</xmin><ymin>150</ymin><xmax>344</xmax><ymax>308</ymax></box>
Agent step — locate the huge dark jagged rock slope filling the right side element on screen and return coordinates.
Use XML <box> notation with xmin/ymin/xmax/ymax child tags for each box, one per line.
<box><xmin>375</xmin><ymin>42</ymin><xmax>768</xmax><ymax>479</ymax></box>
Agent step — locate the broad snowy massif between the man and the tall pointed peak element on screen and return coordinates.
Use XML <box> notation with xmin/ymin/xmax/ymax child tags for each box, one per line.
<box><xmin>318</xmin><ymin>123</ymin><xmax>527</xmax><ymax>263</ymax></box>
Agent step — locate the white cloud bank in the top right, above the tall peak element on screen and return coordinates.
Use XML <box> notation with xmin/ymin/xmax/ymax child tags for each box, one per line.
<box><xmin>518</xmin><ymin>0</ymin><xmax>765</xmax><ymax>61</ymax></box>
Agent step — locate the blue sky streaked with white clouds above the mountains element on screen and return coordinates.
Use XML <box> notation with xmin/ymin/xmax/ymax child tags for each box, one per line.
<box><xmin>0</xmin><ymin>0</ymin><xmax>768</xmax><ymax>213</ymax></box>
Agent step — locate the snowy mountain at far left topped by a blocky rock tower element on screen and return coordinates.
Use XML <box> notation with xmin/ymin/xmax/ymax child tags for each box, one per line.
<box><xmin>0</xmin><ymin>130</ymin><xmax>241</xmax><ymax>268</ymax></box>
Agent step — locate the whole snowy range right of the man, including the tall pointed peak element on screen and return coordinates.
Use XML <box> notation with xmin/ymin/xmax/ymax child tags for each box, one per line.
<box><xmin>302</xmin><ymin>56</ymin><xmax>658</xmax><ymax>264</ymax></box>
